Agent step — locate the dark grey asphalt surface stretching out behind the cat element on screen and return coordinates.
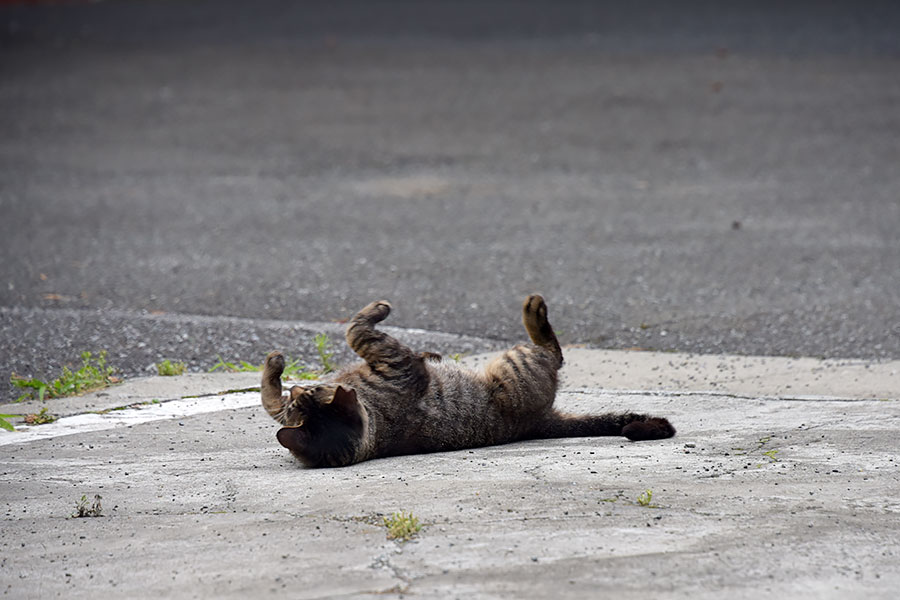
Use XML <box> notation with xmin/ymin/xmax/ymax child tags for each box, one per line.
<box><xmin>0</xmin><ymin>0</ymin><xmax>900</xmax><ymax>394</ymax></box>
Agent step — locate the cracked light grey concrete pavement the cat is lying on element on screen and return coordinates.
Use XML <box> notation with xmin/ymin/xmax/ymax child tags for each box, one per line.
<box><xmin>0</xmin><ymin>348</ymin><xmax>900</xmax><ymax>598</ymax></box>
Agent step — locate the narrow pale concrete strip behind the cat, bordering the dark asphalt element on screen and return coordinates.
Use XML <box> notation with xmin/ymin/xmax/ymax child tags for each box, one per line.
<box><xmin>0</xmin><ymin>347</ymin><xmax>900</xmax><ymax>423</ymax></box>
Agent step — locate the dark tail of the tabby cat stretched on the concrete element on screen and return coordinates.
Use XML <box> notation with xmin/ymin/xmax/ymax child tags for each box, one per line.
<box><xmin>532</xmin><ymin>411</ymin><xmax>675</xmax><ymax>442</ymax></box>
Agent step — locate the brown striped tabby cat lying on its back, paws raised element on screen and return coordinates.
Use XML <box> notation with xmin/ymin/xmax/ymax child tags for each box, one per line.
<box><xmin>261</xmin><ymin>295</ymin><xmax>675</xmax><ymax>467</ymax></box>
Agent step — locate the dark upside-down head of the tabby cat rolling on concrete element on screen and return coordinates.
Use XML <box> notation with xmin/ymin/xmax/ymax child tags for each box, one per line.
<box><xmin>278</xmin><ymin>384</ymin><xmax>367</xmax><ymax>467</ymax></box>
